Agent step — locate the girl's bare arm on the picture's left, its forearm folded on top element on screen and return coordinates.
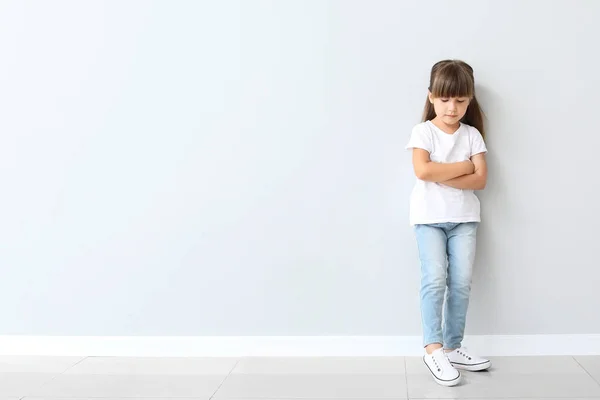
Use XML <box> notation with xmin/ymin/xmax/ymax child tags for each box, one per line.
<box><xmin>413</xmin><ymin>148</ymin><xmax>475</xmax><ymax>186</ymax></box>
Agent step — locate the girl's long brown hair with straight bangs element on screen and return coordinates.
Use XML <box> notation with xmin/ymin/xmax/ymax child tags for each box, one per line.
<box><xmin>423</xmin><ymin>60</ymin><xmax>485</xmax><ymax>138</ymax></box>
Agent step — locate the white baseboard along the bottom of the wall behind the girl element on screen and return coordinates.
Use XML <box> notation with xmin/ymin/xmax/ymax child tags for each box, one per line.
<box><xmin>0</xmin><ymin>334</ymin><xmax>600</xmax><ymax>357</ymax></box>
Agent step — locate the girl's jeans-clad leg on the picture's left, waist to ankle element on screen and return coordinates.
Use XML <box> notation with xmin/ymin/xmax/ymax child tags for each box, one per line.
<box><xmin>415</xmin><ymin>225</ymin><xmax>447</xmax><ymax>347</ymax></box>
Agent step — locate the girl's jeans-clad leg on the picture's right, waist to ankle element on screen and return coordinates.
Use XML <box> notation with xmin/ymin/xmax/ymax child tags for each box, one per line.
<box><xmin>444</xmin><ymin>222</ymin><xmax>479</xmax><ymax>350</ymax></box>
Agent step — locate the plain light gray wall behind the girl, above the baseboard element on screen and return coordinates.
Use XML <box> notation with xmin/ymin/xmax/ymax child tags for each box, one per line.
<box><xmin>0</xmin><ymin>0</ymin><xmax>600</xmax><ymax>335</ymax></box>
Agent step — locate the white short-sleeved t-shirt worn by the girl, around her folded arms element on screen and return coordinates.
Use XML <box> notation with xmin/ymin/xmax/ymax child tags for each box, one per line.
<box><xmin>406</xmin><ymin>121</ymin><xmax>487</xmax><ymax>225</ymax></box>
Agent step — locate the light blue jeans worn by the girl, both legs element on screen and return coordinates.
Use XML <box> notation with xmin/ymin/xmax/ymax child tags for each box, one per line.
<box><xmin>414</xmin><ymin>222</ymin><xmax>479</xmax><ymax>349</ymax></box>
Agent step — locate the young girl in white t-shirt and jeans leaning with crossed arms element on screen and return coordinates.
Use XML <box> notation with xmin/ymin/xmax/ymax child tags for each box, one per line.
<box><xmin>406</xmin><ymin>60</ymin><xmax>491</xmax><ymax>386</ymax></box>
